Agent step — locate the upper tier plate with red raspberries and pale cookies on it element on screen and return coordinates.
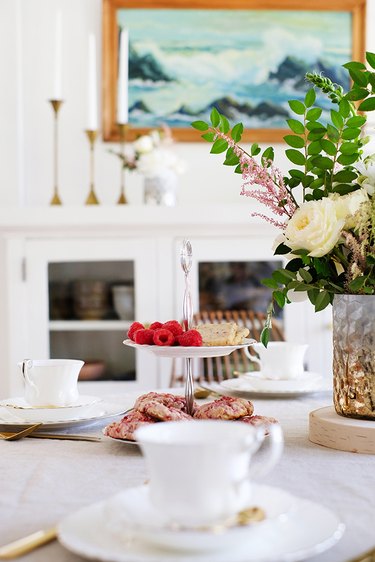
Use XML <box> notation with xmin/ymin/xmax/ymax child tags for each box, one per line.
<box><xmin>123</xmin><ymin>320</ymin><xmax>256</xmax><ymax>358</ymax></box>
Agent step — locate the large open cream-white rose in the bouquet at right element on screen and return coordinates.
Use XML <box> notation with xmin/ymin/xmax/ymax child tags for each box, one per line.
<box><xmin>284</xmin><ymin>197</ymin><xmax>345</xmax><ymax>258</ymax></box>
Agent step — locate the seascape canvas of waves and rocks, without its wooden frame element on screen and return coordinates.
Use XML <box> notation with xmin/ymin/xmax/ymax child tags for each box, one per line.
<box><xmin>117</xmin><ymin>9</ymin><xmax>352</xmax><ymax>129</ymax></box>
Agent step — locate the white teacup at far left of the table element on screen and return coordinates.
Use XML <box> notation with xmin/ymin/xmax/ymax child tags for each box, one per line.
<box><xmin>18</xmin><ymin>359</ymin><xmax>84</xmax><ymax>407</ymax></box>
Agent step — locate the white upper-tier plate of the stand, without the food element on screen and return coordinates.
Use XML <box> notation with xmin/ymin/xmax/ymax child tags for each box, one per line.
<box><xmin>123</xmin><ymin>339</ymin><xmax>256</xmax><ymax>357</ymax></box>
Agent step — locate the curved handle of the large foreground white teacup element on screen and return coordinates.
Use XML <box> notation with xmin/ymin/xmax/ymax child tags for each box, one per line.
<box><xmin>250</xmin><ymin>423</ymin><xmax>284</xmax><ymax>478</ymax></box>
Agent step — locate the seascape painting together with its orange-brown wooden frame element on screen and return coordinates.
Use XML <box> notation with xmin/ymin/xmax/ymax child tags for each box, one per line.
<box><xmin>102</xmin><ymin>0</ymin><xmax>366</xmax><ymax>142</ymax></box>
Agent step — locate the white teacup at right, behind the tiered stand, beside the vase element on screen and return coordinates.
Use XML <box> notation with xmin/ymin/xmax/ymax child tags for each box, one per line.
<box><xmin>245</xmin><ymin>342</ymin><xmax>308</xmax><ymax>380</ymax></box>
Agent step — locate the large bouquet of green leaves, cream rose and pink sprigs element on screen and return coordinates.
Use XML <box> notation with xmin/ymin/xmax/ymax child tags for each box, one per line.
<box><xmin>192</xmin><ymin>52</ymin><xmax>375</xmax><ymax>345</ymax></box>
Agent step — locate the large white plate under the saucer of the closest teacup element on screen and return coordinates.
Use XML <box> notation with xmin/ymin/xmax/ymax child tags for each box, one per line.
<box><xmin>58</xmin><ymin>484</ymin><xmax>344</xmax><ymax>562</ymax></box>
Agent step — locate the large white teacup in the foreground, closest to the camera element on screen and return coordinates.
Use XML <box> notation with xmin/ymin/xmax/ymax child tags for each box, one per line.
<box><xmin>135</xmin><ymin>420</ymin><xmax>283</xmax><ymax>527</ymax></box>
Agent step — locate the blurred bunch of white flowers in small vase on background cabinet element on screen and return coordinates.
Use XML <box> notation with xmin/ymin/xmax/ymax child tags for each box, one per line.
<box><xmin>110</xmin><ymin>127</ymin><xmax>185</xmax><ymax>177</ymax></box>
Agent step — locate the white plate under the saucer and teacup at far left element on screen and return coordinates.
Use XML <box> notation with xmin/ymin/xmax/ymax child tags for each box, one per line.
<box><xmin>0</xmin><ymin>401</ymin><xmax>127</xmax><ymax>431</ymax></box>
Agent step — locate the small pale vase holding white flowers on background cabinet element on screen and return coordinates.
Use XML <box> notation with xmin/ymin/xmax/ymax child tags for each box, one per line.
<box><xmin>143</xmin><ymin>170</ymin><xmax>178</xmax><ymax>207</ymax></box>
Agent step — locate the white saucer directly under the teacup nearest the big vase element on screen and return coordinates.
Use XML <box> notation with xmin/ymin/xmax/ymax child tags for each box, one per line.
<box><xmin>240</xmin><ymin>371</ymin><xmax>323</xmax><ymax>392</ymax></box>
